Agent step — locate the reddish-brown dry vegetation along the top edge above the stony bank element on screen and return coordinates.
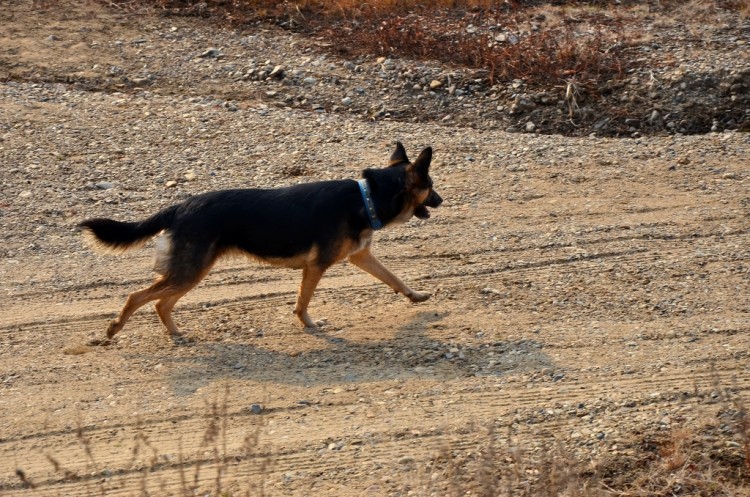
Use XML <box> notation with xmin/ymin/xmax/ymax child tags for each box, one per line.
<box><xmin>101</xmin><ymin>0</ymin><xmax>750</xmax><ymax>92</ymax></box>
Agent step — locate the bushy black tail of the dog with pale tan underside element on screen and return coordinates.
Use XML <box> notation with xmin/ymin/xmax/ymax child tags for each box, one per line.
<box><xmin>78</xmin><ymin>205</ymin><xmax>177</xmax><ymax>252</ymax></box>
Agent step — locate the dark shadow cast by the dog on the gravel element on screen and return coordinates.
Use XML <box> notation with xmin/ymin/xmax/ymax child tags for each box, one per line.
<box><xmin>137</xmin><ymin>313</ymin><xmax>552</xmax><ymax>395</ymax></box>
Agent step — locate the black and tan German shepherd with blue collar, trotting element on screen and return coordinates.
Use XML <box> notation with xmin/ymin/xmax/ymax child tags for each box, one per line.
<box><xmin>79</xmin><ymin>143</ymin><xmax>443</xmax><ymax>338</ymax></box>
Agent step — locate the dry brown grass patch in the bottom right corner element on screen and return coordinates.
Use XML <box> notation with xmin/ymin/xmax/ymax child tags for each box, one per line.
<box><xmin>404</xmin><ymin>374</ymin><xmax>750</xmax><ymax>497</ymax></box>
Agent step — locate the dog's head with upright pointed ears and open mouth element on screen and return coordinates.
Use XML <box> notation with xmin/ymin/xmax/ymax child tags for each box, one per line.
<box><xmin>389</xmin><ymin>142</ymin><xmax>443</xmax><ymax>220</ymax></box>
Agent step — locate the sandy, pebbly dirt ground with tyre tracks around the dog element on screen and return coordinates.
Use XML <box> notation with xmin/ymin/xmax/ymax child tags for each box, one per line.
<box><xmin>0</xmin><ymin>2</ymin><xmax>750</xmax><ymax>496</ymax></box>
